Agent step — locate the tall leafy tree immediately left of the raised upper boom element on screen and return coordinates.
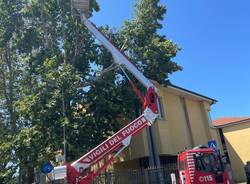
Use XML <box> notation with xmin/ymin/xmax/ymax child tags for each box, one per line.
<box><xmin>11</xmin><ymin>1</ymin><xmax>99</xmax><ymax>183</ymax></box>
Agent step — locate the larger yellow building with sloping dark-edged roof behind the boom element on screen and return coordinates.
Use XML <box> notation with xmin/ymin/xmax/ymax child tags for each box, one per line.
<box><xmin>114</xmin><ymin>83</ymin><xmax>221</xmax><ymax>170</ymax></box>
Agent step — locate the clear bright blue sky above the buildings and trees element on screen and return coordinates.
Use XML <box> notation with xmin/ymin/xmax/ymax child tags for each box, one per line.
<box><xmin>92</xmin><ymin>0</ymin><xmax>250</xmax><ymax>119</ymax></box>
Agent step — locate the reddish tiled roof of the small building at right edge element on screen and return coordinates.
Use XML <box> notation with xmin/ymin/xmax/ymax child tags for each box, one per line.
<box><xmin>213</xmin><ymin>117</ymin><xmax>250</xmax><ymax>127</ymax></box>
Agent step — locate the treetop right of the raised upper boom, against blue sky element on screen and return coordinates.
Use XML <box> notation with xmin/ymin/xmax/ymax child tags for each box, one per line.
<box><xmin>120</xmin><ymin>0</ymin><xmax>182</xmax><ymax>84</ymax></box>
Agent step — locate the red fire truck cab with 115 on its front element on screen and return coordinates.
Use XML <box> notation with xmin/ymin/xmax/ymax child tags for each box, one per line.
<box><xmin>178</xmin><ymin>147</ymin><xmax>230</xmax><ymax>184</ymax></box>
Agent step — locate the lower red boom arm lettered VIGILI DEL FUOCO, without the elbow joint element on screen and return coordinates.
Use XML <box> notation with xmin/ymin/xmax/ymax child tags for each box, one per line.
<box><xmin>67</xmin><ymin>114</ymin><xmax>155</xmax><ymax>184</ymax></box>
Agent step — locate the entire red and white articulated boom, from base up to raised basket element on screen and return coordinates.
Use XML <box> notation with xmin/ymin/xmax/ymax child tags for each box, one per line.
<box><xmin>64</xmin><ymin>0</ymin><xmax>158</xmax><ymax>184</ymax></box>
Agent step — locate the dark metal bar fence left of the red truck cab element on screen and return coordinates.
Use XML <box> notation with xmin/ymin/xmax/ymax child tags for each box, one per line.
<box><xmin>93</xmin><ymin>164</ymin><xmax>178</xmax><ymax>184</ymax></box>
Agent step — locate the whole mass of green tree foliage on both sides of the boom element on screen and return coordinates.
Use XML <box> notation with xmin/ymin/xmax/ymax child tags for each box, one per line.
<box><xmin>0</xmin><ymin>0</ymin><xmax>181</xmax><ymax>183</ymax></box>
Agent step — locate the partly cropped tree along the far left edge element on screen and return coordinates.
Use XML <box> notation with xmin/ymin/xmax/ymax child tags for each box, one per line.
<box><xmin>0</xmin><ymin>0</ymin><xmax>23</xmax><ymax>183</ymax></box>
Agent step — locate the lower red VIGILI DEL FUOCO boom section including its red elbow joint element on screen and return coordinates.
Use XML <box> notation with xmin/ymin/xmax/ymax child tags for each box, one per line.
<box><xmin>65</xmin><ymin>87</ymin><xmax>158</xmax><ymax>184</ymax></box>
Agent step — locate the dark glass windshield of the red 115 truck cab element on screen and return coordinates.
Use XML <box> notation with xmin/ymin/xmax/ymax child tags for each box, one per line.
<box><xmin>195</xmin><ymin>153</ymin><xmax>223</xmax><ymax>172</ymax></box>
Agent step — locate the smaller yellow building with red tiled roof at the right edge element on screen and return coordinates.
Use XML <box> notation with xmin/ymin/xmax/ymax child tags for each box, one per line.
<box><xmin>213</xmin><ymin>117</ymin><xmax>250</xmax><ymax>182</ymax></box>
